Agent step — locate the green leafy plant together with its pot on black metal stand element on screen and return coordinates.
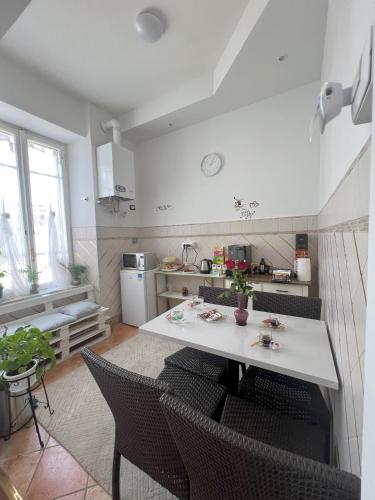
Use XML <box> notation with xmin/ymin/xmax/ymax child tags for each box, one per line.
<box><xmin>0</xmin><ymin>327</ymin><xmax>56</xmax><ymax>393</ymax></box>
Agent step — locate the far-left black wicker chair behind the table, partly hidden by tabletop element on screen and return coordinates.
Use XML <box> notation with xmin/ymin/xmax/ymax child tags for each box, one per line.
<box><xmin>164</xmin><ymin>286</ymin><xmax>247</xmax><ymax>383</ymax></box>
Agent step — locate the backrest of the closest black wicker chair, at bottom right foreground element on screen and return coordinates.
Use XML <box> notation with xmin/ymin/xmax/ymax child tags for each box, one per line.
<box><xmin>160</xmin><ymin>394</ymin><xmax>360</xmax><ymax>500</ymax></box>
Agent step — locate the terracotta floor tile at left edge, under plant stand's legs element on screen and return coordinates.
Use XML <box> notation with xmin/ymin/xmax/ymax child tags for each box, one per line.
<box><xmin>0</xmin><ymin>424</ymin><xmax>48</xmax><ymax>463</ymax></box>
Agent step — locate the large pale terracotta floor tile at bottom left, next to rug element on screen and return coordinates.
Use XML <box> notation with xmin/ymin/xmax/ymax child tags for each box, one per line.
<box><xmin>25</xmin><ymin>446</ymin><xmax>87</xmax><ymax>500</ymax></box>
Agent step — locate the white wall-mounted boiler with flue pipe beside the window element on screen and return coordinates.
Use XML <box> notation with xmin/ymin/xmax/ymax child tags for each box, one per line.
<box><xmin>96</xmin><ymin>120</ymin><xmax>135</xmax><ymax>202</ymax></box>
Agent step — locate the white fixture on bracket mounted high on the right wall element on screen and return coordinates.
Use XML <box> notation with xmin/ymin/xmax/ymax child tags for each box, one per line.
<box><xmin>310</xmin><ymin>27</ymin><xmax>374</xmax><ymax>138</ymax></box>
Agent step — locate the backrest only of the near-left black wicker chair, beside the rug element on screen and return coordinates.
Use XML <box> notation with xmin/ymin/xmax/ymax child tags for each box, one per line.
<box><xmin>81</xmin><ymin>347</ymin><xmax>189</xmax><ymax>498</ymax></box>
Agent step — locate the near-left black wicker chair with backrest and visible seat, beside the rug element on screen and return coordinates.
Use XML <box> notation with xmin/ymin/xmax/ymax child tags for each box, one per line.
<box><xmin>81</xmin><ymin>347</ymin><xmax>225</xmax><ymax>500</ymax></box>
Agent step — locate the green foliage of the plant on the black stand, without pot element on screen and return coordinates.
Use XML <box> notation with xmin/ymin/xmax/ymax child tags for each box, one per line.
<box><xmin>0</xmin><ymin>327</ymin><xmax>56</xmax><ymax>378</ymax></box>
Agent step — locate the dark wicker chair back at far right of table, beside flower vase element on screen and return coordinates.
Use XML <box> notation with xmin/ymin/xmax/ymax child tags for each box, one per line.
<box><xmin>253</xmin><ymin>292</ymin><xmax>322</xmax><ymax>319</ymax></box>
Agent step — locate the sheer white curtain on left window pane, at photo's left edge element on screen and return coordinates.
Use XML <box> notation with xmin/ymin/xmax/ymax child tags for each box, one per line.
<box><xmin>0</xmin><ymin>212</ymin><xmax>29</xmax><ymax>297</ymax></box>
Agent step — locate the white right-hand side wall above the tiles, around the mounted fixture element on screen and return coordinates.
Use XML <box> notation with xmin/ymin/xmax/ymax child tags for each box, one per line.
<box><xmin>319</xmin><ymin>0</ymin><xmax>373</xmax><ymax>208</ymax></box>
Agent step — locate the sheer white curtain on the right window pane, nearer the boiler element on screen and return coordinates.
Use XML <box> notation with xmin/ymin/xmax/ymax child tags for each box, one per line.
<box><xmin>48</xmin><ymin>210</ymin><xmax>70</xmax><ymax>288</ymax></box>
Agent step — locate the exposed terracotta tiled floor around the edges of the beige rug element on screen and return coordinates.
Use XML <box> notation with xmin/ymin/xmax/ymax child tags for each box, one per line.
<box><xmin>0</xmin><ymin>325</ymin><xmax>137</xmax><ymax>500</ymax></box>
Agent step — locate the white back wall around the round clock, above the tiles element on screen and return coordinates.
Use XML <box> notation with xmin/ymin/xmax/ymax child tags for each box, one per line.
<box><xmin>135</xmin><ymin>82</ymin><xmax>319</xmax><ymax>226</ymax></box>
